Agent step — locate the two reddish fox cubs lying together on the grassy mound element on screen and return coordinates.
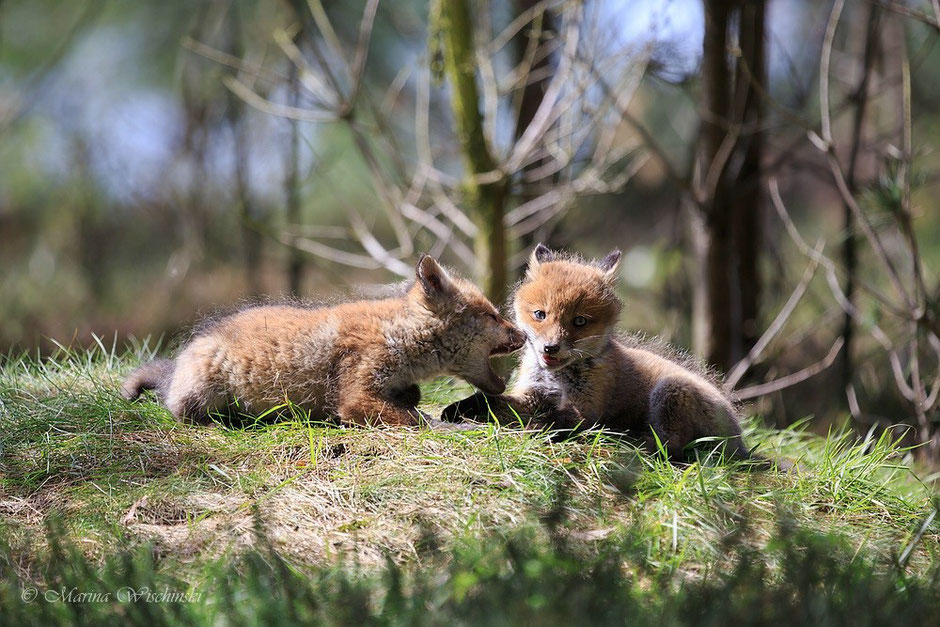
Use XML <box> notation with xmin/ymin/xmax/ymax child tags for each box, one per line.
<box><xmin>123</xmin><ymin>244</ymin><xmax>749</xmax><ymax>457</ymax></box>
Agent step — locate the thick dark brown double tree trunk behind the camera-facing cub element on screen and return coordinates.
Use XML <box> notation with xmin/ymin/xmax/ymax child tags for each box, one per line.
<box><xmin>693</xmin><ymin>0</ymin><xmax>766</xmax><ymax>370</ymax></box>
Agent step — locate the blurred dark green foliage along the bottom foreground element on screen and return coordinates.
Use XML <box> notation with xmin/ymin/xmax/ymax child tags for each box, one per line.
<box><xmin>0</xmin><ymin>510</ymin><xmax>940</xmax><ymax>625</ymax></box>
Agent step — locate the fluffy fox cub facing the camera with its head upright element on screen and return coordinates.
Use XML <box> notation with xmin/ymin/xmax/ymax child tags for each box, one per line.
<box><xmin>443</xmin><ymin>244</ymin><xmax>749</xmax><ymax>457</ymax></box>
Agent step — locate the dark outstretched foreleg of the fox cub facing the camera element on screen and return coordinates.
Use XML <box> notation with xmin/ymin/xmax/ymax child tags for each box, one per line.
<box><xmin>441</xmin><ymin>392</ymin><xmax>581</xmax><ymax>429</ymax></box>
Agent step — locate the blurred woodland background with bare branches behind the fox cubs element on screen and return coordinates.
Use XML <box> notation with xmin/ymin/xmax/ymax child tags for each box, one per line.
<box><xmin>0</xmin><ymin>0</ymin><xmax>940</xmax><ymax>458</ymax></box>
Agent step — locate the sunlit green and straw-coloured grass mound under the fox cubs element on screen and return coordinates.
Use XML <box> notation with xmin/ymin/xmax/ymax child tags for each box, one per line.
<box><xmin>0</xmin><ymin>343</ymin><xmax>940</xmax><ymax>624</ymax></box>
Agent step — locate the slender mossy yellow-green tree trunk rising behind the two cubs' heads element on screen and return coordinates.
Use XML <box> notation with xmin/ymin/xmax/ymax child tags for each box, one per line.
<box><xmin>436</xmin><ymin>0</ymin><xmax>508</xmax><ymax>303</ymax></box>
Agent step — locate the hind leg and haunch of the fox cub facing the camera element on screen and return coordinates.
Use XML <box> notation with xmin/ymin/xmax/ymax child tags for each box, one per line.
<box><xmin>649</xmin><ymin>378</ymin><xmax>749</xmax><ymax>458</ymax></box>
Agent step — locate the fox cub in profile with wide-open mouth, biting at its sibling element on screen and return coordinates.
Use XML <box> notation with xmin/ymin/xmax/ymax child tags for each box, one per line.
<box><xmin>123</xmin><ymin>255</ymin><xmax>524</xmax><ymax>425</ymax></box>
